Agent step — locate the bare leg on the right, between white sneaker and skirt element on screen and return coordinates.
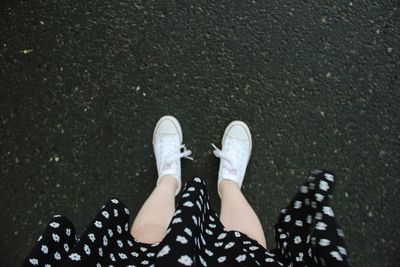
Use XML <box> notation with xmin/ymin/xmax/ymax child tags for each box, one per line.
<box><xmin>219</xmin><ymin>179</ymin><xmax>267</xmax><ymax>248</ymax></box>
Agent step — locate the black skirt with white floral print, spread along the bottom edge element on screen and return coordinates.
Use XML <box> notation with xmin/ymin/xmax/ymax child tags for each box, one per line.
<box><xmin>22</xmin><ymin>171</ymin><xmax>349</xmax><ymax>267</ymax></box>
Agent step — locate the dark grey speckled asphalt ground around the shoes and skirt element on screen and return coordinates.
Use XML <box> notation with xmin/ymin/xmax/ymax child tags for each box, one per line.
<box><xmin>0</xmin><ymin>0</ymin><xmax>400</xmax><ymax>266</ymax></box>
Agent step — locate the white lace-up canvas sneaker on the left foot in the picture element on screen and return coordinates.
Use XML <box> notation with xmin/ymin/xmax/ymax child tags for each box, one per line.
<box><xmin>153</xmin><ymin>116</ymin><xmax>193</xmax><ymax>195</ymax></box>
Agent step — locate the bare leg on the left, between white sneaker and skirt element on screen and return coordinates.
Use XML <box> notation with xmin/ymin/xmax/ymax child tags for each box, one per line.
<box><xmin>131</xmin><ymin>175</ymin><xmax>178</xmax><ymax>243</ymax></box>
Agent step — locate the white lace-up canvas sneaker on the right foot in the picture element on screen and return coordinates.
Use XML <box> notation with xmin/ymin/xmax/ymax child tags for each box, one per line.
<box><xmin>212</xmin><ymin>121</ymin><xmax>252</xmax><ymax>197</ymax></box>
